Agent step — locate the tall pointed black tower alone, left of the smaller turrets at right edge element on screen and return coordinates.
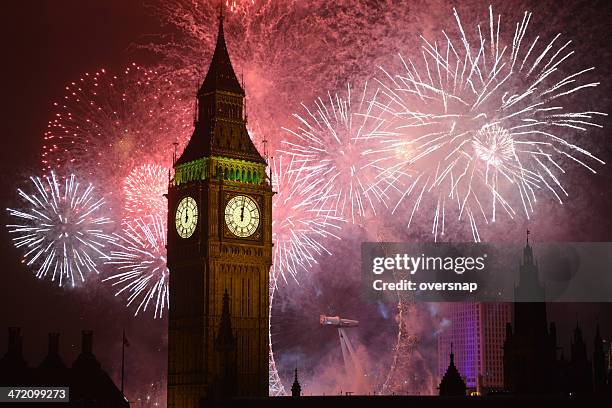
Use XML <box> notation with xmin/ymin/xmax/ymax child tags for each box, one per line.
<box><xmin>504</xmin><ymin>239</ymin><xmax>558</xmax><ymax>394</ymax></box>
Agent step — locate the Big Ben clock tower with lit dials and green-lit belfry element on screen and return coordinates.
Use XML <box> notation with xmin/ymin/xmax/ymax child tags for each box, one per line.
<box><xmin>168</xmin><ymin>10</ymin><xmax>272</xmax><ymax>408</ymax></box>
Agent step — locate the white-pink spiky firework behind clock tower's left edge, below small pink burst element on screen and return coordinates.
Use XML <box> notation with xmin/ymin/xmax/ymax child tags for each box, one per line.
<box><xmin>103</xmin><ymin>216</ymin><xmax>170</xmax><ymax>318</ymax></box>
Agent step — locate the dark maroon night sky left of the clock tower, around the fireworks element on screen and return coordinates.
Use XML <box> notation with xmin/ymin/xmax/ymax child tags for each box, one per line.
<box><xmin>0</xmin><ymin>1</ymin><xmax>167</xmax><ymax>404</ymax></box>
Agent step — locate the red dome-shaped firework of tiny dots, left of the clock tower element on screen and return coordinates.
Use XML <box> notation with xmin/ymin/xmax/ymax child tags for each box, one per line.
<box><xmin>42</xmin><ymin>64</ymin><xmax>193</xmax><ymax>178</ymax></box>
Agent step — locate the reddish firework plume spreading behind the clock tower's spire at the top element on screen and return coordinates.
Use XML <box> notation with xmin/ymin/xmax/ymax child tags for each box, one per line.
<box><xmin>142</xmin><ymin>0</ymin><xmax>428</xmax><ymax>151</ymax></box>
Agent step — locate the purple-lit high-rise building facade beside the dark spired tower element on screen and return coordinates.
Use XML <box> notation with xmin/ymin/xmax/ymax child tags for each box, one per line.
<box><xmin>438</xmin><ymin>302</ymin><xmax>512</xmax><ymax>393</ymax></box>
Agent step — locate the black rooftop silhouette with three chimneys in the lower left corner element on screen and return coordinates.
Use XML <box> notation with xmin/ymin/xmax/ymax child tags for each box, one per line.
<box><xmin>0</xmin><ymin>327</ymin><xmax>130</xmax><ymax>408</ymax></box>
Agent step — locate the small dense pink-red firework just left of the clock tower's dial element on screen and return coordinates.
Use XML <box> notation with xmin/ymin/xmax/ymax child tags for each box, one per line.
<box><xmin>123</xmin><ymin>164</ymin><xmax>168</xmax><ymax>220</ymax></box>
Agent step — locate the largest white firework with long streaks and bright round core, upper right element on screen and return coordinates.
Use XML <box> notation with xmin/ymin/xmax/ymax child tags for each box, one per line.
<box><xmin>379</xmin><ymin>7</ymin><xmax>605</xmax><ymax>241</ymax></box>
